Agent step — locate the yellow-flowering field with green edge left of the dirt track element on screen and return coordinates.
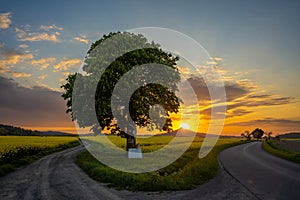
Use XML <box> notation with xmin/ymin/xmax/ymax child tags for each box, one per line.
<box><xmin>0</xmin><ymin>136</ymin><xmax>79</xmax><ymax>176</ymax></box>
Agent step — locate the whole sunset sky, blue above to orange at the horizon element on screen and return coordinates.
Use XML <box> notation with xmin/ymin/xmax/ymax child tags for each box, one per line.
<box><xmin>0</xmin><ymin>0</ymin><xmax>300</xmax><ymax>135</ymax></box>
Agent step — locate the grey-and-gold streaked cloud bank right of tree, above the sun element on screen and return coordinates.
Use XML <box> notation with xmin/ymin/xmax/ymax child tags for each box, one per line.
<box><xmin>179</xmin><ymin>73</ymin><xmax>294</xmax><ymax>119</ymax></box>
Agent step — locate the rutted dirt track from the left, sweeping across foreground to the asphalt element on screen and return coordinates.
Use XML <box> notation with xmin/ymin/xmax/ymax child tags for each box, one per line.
<box><xmin>0</xmin><ymin>146</ymin><xmax>256</xmax><ymax>200</ymax></box>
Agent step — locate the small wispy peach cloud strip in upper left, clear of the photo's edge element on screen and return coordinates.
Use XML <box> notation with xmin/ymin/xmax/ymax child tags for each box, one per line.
<box><xmin>15</xmin><ymin>24</ymin><xmax>63</xmax><ymax>42</ymax></box>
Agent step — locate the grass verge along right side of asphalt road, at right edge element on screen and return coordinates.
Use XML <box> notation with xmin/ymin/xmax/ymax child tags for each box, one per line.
<box><xmin>262</xmin><ymin>141</ymin><xmax>300</xmax><ymax>163</ymax></box>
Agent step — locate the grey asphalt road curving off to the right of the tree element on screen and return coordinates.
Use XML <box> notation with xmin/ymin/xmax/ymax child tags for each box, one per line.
<box><xmin>219</xmin><ymin>142</ymin><xmax>300</xmax><ymax>199</ymax></box>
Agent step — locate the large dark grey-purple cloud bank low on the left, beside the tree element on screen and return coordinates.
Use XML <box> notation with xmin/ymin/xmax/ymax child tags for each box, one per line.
<box><xmin>0</xmin><ymin>76</ymin><xmax>73</xmax><ymax>127</ymax></box>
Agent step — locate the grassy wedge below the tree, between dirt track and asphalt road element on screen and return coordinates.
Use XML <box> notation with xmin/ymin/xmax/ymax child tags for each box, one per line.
<box><xmin>76</xmin><ymin>137</ymin><xmax>245</xmax><ymax>191</ymax></box>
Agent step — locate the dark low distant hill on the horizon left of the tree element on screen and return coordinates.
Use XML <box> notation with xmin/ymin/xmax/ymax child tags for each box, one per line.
<box><xmin>0</xmin><ymin>124</ymin><xmax>73</xmax><ymax>136</ymax></box>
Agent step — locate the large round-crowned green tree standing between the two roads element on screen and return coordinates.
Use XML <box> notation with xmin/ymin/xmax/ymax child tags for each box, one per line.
<box><xmin>61</xmin><ymin>32</ymin><xmax>180</xmax><ymax>148</ymax></box>
